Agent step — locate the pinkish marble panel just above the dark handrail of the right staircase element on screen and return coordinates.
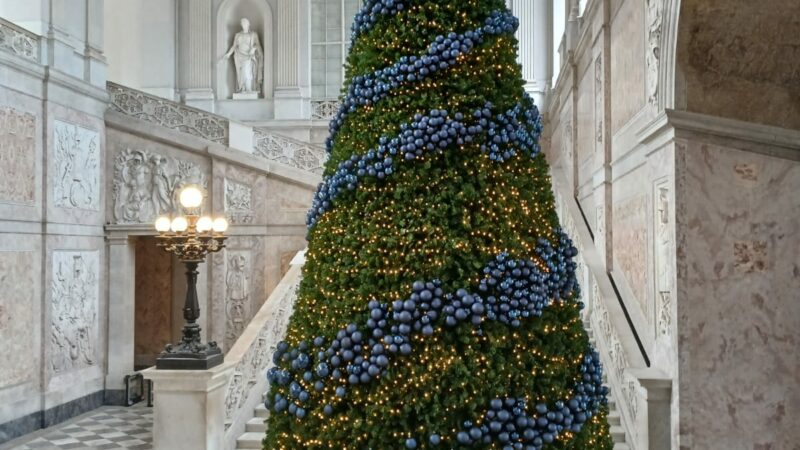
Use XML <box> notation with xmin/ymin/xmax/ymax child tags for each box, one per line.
<box><xmin>611</xmin><ymin>195</ymin><xmax>652</xmax><ymax>320</ymax></box>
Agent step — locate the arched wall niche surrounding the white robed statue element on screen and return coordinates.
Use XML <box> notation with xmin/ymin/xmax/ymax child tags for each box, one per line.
<box><xmin>215</xmin><ymin>0</ymin><xmax>275</xmax><ymax>99</ymax></box>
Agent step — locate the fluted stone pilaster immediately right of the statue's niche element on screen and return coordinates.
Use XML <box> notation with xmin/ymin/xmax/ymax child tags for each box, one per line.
<box><xmin>275</xmin><ymin>0</ymin><xmax>308</xmax><ymax>119</ymax></box>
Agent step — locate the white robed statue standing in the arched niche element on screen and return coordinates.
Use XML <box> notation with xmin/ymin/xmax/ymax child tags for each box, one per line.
<box><xmin>222</xmin><ymin>19</ymin><xmax>264</xmax><ymax>98</ymax></box>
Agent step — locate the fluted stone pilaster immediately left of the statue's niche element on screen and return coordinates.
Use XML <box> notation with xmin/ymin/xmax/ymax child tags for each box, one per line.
<box><xmin>178</xmin><ymin>0</ymin><xmax>214</xmax><ymax>112</ymax></box>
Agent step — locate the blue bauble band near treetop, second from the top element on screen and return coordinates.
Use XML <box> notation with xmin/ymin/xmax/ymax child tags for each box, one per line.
<box><xmin>325</xmin><ymin>11</ymin><xmax>519</xmax><ymax>152</ymax></box>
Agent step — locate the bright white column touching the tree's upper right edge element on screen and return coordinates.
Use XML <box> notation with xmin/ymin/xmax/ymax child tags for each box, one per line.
<box><xmin>512</xmin><ymin>0</ymin><xmax>553</xmax><ymax>110</ymax></box>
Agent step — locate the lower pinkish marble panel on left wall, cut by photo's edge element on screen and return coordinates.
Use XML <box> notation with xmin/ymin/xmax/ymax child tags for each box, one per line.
<box><xmin>0</xmin><ymin>251</ymin><xmax>38</xmax><ymax>388</ymax></box>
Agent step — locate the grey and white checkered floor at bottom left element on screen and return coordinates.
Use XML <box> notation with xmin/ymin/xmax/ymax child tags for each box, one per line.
<box><xmin>0</xmin><ymin>402</ymin><xmax>153</xmax><ymax>450</ymax></box>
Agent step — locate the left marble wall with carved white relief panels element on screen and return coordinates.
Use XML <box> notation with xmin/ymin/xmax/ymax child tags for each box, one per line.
<box><xmin>0</xmin><ymin>36</ymin><xmax>108</xmax><ymax>441</ymax></box>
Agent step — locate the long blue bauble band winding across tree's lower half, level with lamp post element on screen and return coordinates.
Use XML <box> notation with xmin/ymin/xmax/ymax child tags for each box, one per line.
<box><xmin>266</xmin><ymin>230</ymin><xmax>592</xmax><ymax>419</ymax></box>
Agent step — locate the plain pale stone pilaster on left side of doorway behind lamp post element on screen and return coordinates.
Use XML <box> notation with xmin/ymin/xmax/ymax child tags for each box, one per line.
<box><xmin>106</xmin><ymin>235</ymin><xmax>136</xmax><ymax>404</ymax></box>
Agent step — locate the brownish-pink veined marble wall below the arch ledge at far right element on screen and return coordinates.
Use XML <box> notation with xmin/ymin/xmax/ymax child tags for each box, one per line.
<box><xmin>677</xmin><ymin>139</ymin><xmax>800</xmax><ymax>449</ymax></box>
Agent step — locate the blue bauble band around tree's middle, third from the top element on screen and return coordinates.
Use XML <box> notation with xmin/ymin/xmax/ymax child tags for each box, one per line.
<box><xmin>306</xmin><ymin>95</ymin><xmax>541</xmax><ymax>228</ymax></box>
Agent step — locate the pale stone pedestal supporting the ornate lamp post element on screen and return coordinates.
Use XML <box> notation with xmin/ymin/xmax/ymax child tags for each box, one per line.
<box><xmin>142</xmin><ymin>364</ymin><xmax>234</xmax><ymax>450</ymax></box>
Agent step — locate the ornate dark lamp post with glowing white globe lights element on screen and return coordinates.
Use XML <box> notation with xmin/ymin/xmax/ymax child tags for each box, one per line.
<box><xmin>155</xmin><ymin>186</ymin><xmax>228</xmax><ymax>370</ymax></box>
